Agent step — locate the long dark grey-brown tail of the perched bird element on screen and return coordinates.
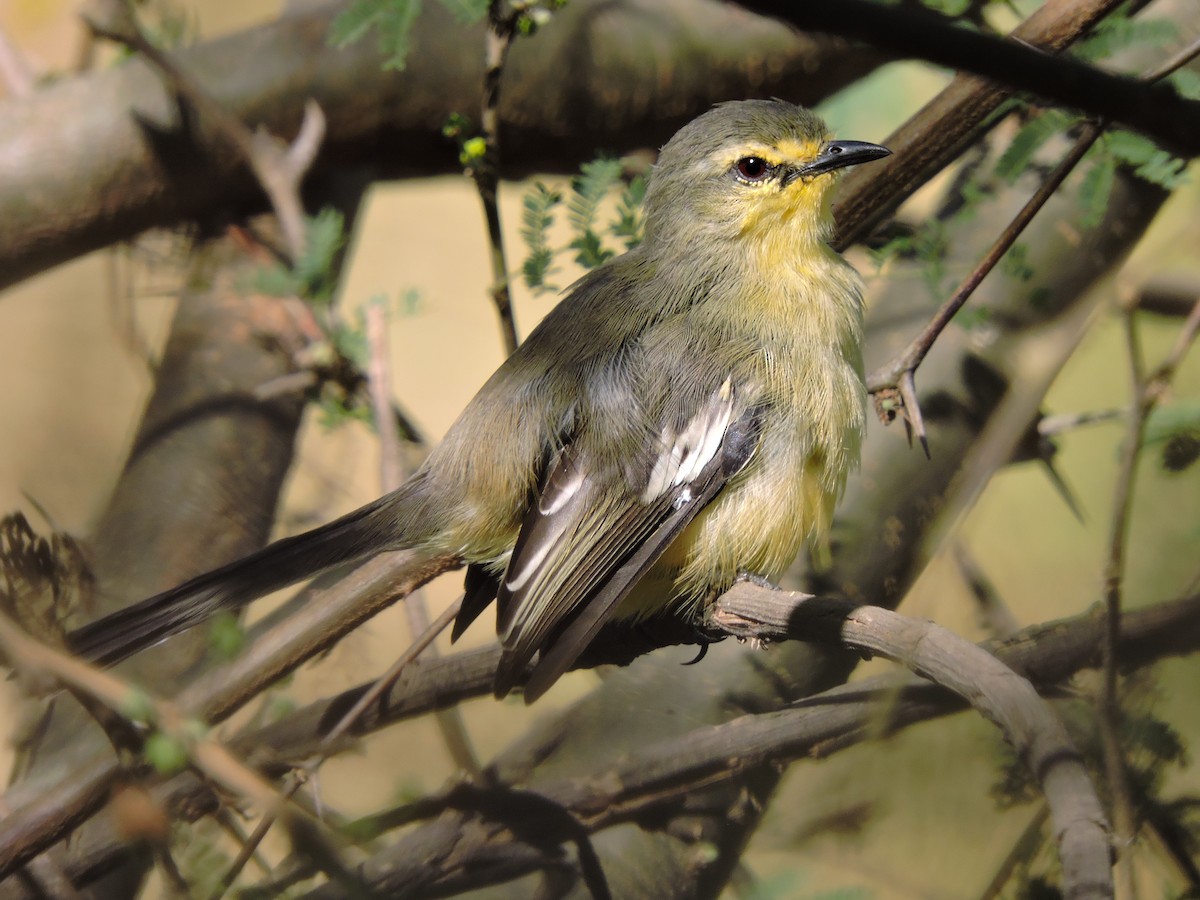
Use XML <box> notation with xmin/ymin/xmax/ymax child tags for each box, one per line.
<box><xmin>67</xmin><ymin>482</ymin><xmax>419</xmax><ymax>666</ymax></box>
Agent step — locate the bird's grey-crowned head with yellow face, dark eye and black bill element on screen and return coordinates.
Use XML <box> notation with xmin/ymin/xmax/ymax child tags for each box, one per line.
<box><xmin>646</xmin><ymin>100</ymin><xmax>890</xmax><ymax>252</ymax></box>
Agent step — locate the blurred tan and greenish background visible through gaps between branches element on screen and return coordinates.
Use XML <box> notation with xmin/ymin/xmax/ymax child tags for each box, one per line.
<box><xmin>0</xmin><ymin>0</ymin><xmax>1200</xmax><ymax>900</ymax></box>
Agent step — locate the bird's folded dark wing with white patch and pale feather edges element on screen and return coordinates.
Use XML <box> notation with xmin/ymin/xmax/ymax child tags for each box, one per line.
<box><xmin>496</xmin><ymin>382</ymin><xmax>758</xmax><ymax>702</ymax></box>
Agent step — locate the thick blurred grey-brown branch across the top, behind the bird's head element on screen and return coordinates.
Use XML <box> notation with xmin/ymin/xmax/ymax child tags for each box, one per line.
<box><xmin>0</xmin><ymin>0</ymin><xmax>881</xmax><ymax>288</ymax></box>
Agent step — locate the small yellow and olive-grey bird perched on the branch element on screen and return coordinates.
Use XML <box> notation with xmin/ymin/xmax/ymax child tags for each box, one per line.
<box><xmin>68</xmin><ymin>100</ymin><xmax>889</xmax><ymax>702</ymax></box>
